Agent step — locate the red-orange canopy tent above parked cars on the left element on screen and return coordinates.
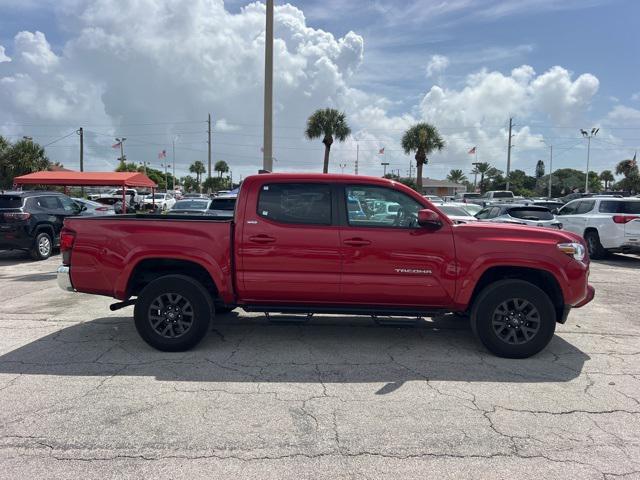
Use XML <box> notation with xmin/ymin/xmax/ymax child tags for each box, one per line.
<box><xmin>13</xmin><ymin>172</ymin><xmax>157</xmax><ymax>213</ymax></box>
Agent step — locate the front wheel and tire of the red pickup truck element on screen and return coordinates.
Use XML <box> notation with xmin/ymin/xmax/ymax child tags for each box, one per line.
<box><xmin>471</xmin><ymin>279</ymin><xmax>556</xmax><ymax>358</ymax></box>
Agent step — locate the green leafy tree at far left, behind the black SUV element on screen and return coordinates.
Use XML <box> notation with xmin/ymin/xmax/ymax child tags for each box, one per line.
<box><xmin>0</xmin><ymin>137</ymin><xmax>51</xmax><ymax>188</ymax></box>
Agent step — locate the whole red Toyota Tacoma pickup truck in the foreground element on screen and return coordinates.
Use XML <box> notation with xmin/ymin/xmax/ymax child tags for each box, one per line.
<box><xmin>58</xmin><ymin>173</ymin><xmax>594</xmax><ymax>358</ymax></box>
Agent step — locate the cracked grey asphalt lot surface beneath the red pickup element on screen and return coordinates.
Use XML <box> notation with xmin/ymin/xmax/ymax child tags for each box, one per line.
<box><xmin>0</xmin><ymin>252</ymin><xmax>640</xmax><ymax>479</ymax></box>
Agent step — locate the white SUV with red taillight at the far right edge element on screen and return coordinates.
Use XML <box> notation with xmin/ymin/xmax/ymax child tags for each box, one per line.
<box><xmin>557</xmin><ymin>197</ymin><xmax>640</xmax><ymax>259</ymax></box>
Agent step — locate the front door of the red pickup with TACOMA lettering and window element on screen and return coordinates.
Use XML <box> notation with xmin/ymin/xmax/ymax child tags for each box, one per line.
<box><xmin>340</xmin><ymin>185</ymin><xmax>456</xmax><ymax>307</ymax></box>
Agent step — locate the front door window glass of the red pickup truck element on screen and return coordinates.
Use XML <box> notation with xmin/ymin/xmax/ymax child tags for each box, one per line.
<box><xmin>344</xmin><ymin>185</ymin><xmax>423</xmax><ymax>228</ymax></box>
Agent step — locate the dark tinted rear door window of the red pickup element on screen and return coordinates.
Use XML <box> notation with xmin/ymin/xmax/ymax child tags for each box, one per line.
<box><xmin>258</xmin><ymin>183</ymin><xmax>331</xmax><ymax>225</ymax></box>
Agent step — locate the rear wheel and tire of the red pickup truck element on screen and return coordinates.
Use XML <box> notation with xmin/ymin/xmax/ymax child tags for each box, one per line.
<box><xmin>134</xmin><ymin>275</ymin><xmax>214</xmax><ymax>352</ymax></box>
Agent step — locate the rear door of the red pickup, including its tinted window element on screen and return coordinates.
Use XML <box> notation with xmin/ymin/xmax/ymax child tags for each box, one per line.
<box><xmin>236</xmin><ymin>182</ymin><xmax>340</xmax><ymax>304</ymax></box>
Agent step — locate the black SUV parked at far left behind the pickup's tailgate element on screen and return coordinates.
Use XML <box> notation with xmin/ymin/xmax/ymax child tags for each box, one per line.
<box><xmin>0</xmin><ymin>191</ymin><xmax>82</xmax><ymax>260</ymax></box>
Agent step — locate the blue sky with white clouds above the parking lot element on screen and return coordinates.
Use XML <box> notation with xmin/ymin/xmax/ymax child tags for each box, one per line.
<box><xmin>0</xmin><ymin>0</ymin><xmax>640</xmax><ymax>184</ymax></box>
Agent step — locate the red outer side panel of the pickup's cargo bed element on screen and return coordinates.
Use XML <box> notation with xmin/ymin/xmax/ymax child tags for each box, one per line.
<box><xmin>65</xmin><ymin>214</ymin><xmax>233</xmax><ymax>300</ymax></box>
